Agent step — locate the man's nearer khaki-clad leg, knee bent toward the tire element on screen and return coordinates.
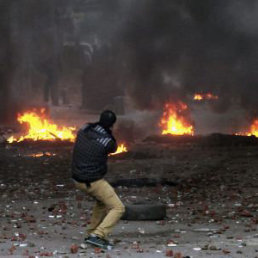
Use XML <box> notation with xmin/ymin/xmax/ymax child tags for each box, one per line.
<box><xmin>89</xmin><ymin>179</ymin><xmax>125</xmax><ymax>238</ymax></box>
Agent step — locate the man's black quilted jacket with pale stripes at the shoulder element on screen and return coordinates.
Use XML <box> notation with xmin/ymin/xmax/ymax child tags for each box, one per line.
<box><xmin>72</xmin><ymin>123</ymin><xmax>117</xmax><ymax>183</ymax></box>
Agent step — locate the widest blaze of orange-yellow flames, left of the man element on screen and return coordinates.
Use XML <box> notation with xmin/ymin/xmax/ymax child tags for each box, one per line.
<box><xmin>7</xmin><ymin>108</ymin><xmax>75</xmax><ymax>143</ymax></box>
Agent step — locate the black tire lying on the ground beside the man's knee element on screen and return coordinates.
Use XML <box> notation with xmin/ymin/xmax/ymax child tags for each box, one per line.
<box><xmin>122</xmin><ymin>203</ymin><xmax>166</xmax><ymax>220</ymax></box>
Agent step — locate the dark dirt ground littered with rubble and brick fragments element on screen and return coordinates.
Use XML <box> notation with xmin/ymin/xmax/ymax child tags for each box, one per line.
<box><xmin>0</xmin><ymin>143</ymin><xmax>258</xmax><ymax>258</ymax></box>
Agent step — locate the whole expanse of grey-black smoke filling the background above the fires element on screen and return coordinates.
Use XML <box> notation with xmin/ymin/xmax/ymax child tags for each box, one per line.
<box><xmin>0</xmin><ymin>0</ymin><xmax>258</xmax><ymax>128</ymax></box>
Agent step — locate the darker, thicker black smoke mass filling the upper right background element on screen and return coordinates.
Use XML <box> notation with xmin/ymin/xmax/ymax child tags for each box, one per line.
<box><xmin>117</xmin><ymin>0</ymin><xmax>258</xmax><ymax>119</ymax></box>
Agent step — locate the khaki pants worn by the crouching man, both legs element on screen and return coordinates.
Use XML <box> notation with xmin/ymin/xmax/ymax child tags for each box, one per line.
<box><xmin>75</xmin><ymin>179</ymin><xmax>125</xmax><ymax>238</ymax></box>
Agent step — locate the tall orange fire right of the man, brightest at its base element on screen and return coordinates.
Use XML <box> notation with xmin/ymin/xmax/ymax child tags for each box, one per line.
<box><xmin>160</xmin><ymin>101</ymin><xmax>194</xmax><ymax>135</ymax></box>
